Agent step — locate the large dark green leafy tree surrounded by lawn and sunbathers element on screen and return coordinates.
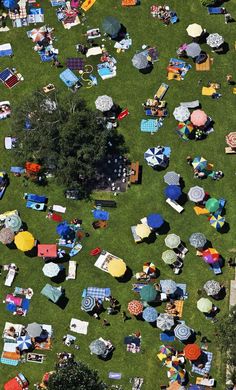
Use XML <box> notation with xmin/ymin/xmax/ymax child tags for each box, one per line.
<box><xmin>13</xmin><ymin>91</ymin><xmax>125</xmax><ymax>196</ymax></box>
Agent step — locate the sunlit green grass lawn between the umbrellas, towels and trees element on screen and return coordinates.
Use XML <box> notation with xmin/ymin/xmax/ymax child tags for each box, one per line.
<box><xmin>0</xmin><ymin>0</ymin><xmax>236</xmax><ymax>390</ymax></box>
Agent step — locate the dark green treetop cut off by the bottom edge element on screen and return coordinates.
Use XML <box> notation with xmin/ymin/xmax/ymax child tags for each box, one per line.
<box><xmin>48</xmin><ymin>362</ymin><xmax>107</xmax><ymax>390</ymax></box>
